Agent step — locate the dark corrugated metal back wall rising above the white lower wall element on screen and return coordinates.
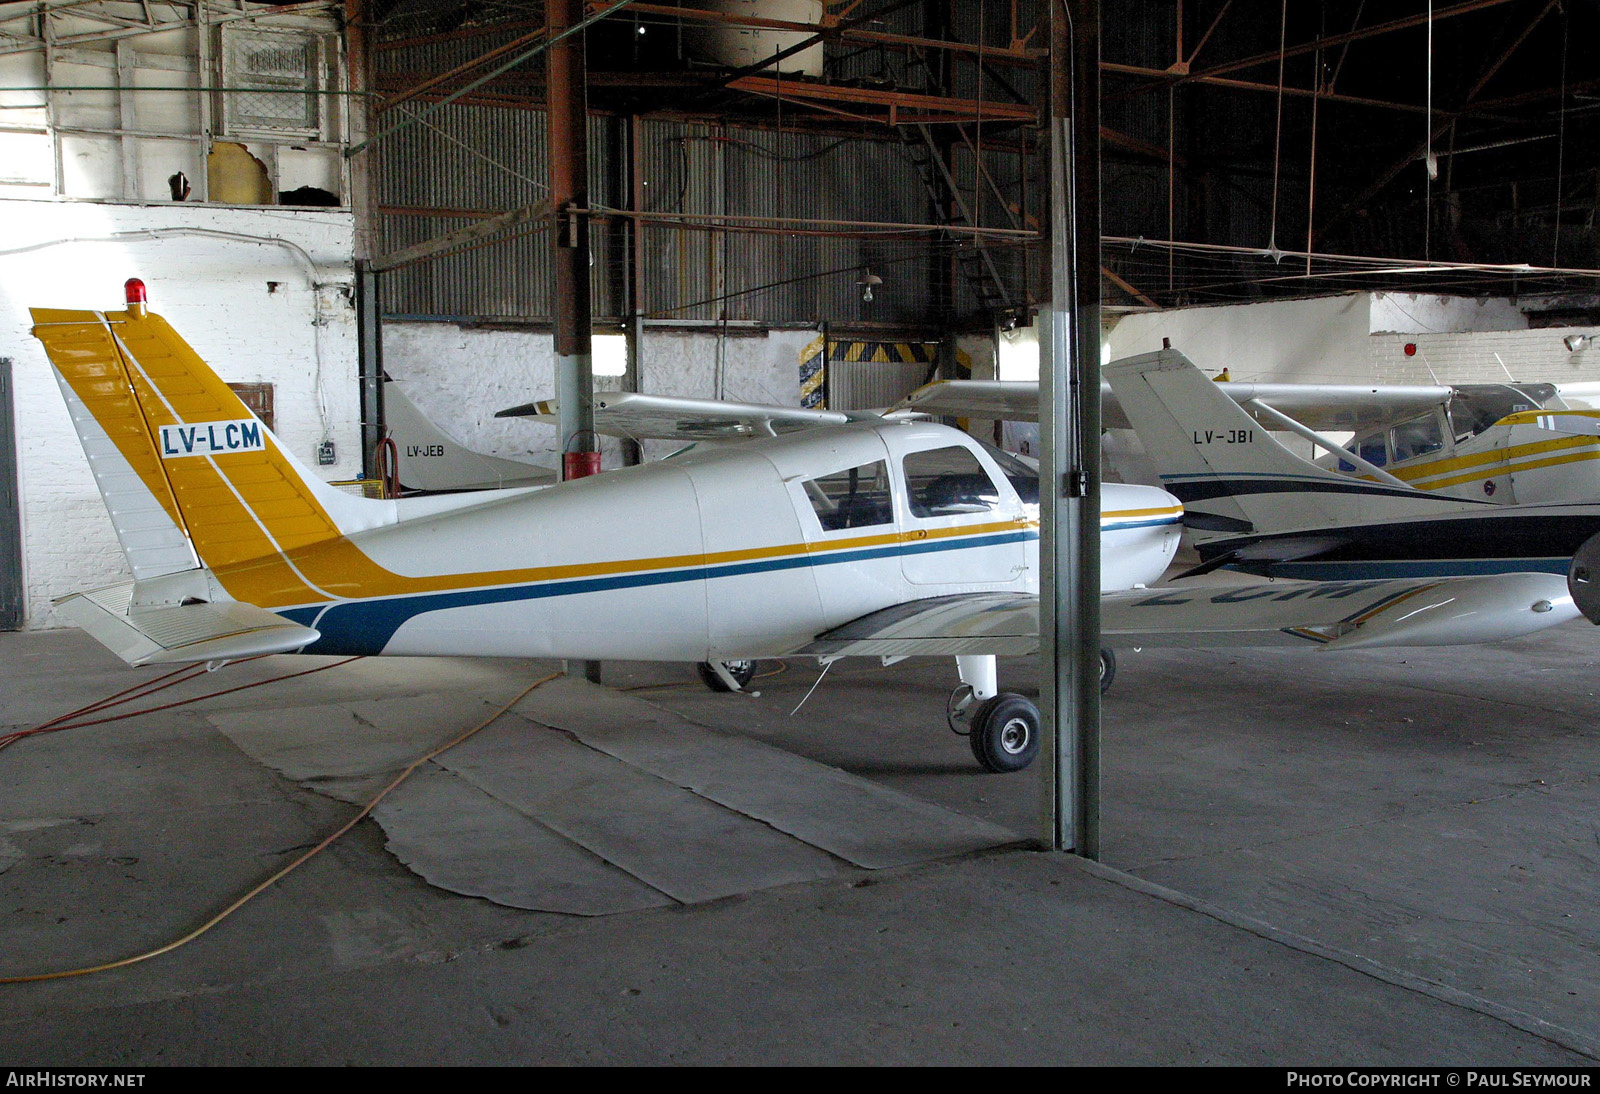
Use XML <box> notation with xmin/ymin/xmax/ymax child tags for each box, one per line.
<box><xmin>373</xmin><ymin>0</ymin><xmax>1038</xmax><ymax>326</ymax></box>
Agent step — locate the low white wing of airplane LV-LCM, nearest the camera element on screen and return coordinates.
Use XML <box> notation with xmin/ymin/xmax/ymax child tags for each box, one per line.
<box><xmin>797</xmin><ymin>574</ymin><xmax>1579</xmax><ymax>659</ymax></box>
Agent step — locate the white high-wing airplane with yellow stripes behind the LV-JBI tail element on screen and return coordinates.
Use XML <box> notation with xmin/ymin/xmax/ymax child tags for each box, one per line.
<box><xmin>896</xmin><ymin>381</ymin><xmax>1600</xmax><ymax>504</ymax></box>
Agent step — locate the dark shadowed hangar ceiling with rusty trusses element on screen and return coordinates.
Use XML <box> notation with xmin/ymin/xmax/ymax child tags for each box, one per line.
<box><xmin>370</xmin><ymin>0</ymin><xmax>1600</xmax><ymax>311</ymax></box>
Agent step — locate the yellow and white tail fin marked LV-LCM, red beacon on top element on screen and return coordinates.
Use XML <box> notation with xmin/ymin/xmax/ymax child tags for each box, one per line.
<box><xmin>32</xmin><ymin>286</ymin><xmax>397</xmax><ymax>581</ymax></box>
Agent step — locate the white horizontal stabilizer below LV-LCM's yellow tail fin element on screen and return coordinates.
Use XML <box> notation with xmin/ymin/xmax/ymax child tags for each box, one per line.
<box><xmin>56</xmin><ymin>582</ymin><xmax>322</xmax><ymax>665</ymax></box>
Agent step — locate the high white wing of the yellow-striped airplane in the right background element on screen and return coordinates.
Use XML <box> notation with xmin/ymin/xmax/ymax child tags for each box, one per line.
<box><xmin>894</xmin><ymin>381</ymin><xmax>1450</xmax><ymax>430</ymax></box>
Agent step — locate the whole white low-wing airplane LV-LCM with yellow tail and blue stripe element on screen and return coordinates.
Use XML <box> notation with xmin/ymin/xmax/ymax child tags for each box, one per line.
<box><xmin>34</xmin><ymin>280</ymin><xmax>1578</xmax><ymax>771</ymax></box>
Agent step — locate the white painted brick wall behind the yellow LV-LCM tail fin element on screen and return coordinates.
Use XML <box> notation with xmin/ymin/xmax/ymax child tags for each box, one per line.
<box><xmin>0</xmin><ymin>200</ymin><xmax>362</xmax><ymax>629</ymax></box>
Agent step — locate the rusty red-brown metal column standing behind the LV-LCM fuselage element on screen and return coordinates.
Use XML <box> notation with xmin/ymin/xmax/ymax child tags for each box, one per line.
<box><xmin>544</xmin><ymin>0</ymin><xmax>600</xmax><ymax>683</ymax></box>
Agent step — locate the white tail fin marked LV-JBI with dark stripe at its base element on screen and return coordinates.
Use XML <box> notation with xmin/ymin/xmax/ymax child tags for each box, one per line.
<box><xmin>1102</xmin><ymin>349</ymin><xmax>1414</xmax><ymax>533</ymax></box>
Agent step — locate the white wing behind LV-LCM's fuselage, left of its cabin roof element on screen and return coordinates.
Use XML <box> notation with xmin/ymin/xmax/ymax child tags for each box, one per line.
<box><xmin>494</xmin><ymin>392</ymin><xmax>851</xmax><ymax>441</ymax></box>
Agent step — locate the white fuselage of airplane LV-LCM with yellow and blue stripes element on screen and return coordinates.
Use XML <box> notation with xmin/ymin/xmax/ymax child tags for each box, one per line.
<box><xmin>262</xmin><ymin>421</ymin><xmax>1182</xmax><ymax>661</ymax></box>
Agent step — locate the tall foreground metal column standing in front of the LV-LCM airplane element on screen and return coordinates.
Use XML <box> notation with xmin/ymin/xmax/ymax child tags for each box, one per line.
<box><xmin>1038</xmin><ymin>0</ymin><xmax>1101</xmax><ymax>859</ymax></box>
